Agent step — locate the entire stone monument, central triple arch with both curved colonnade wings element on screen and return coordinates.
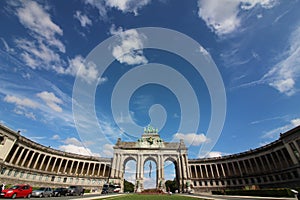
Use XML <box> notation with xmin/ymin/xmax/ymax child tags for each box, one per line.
<box><xmin>0</xmin><ymin>124</ymin><xmax>300</xmax><ymax>192</ymax></box>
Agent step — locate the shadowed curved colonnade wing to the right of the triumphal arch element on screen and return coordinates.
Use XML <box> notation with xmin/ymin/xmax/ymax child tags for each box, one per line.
<box><xmin>189</xmin><ymin>126</ymin><xmax>300</xmax><ymax>192</ymax></box>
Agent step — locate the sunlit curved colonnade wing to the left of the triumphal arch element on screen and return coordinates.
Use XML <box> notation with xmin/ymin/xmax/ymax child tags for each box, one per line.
<box><xmin>0</xmin><ymin>125</ymin><xmax>111</xmax><ymax>189</ymax></box>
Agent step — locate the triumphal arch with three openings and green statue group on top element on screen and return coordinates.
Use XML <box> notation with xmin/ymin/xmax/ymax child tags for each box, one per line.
<box><xmin>109</xmin><ymin>126</ymin><xmax>190</xmax><ymax>192</ymax></box>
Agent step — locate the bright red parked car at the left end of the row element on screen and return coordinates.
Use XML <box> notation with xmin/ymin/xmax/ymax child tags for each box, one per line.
<box><xmin>0</xmin><ymin>184</ymin><xmax>32</xmax><ymax>199</ymax></box>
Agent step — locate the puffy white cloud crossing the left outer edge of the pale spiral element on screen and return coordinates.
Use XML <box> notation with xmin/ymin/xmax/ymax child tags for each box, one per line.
<box><xmin>63</xmin><ymin>56</ymin><xmax>99</xmax><ymax>83</ymax></box>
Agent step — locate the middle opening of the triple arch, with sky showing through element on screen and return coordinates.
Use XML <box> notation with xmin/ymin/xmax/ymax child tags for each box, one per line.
<box><xmin>144</xmin><ymin>158</ymin><xmax>157</xmax><ymax>189</ymax></box>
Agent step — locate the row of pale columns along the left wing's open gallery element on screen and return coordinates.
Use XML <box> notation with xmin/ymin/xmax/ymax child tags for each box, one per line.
<box><xmin>5</xmin><ymin>144</ymin><xmax>110</xmax><ymax>177</ymax></box>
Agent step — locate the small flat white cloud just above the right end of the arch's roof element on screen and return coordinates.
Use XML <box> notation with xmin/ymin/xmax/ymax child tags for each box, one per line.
<box><xmin>173</xmin><ymin>133</ymin><xmax>208</xmax><ymax>146</ymax></box>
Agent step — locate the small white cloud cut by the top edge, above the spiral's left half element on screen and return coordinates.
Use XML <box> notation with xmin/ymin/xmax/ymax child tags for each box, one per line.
<box><xmin>106</xmin><ymin>0</ymin><xmax>151</xmax><ymax>15</ymax></box>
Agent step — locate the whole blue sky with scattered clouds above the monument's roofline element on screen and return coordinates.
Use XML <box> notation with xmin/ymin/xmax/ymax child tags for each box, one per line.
<box><xmin>0</xmin><ymin>0</ymin><xmax>300</xmax><ymax>162</ymax></box>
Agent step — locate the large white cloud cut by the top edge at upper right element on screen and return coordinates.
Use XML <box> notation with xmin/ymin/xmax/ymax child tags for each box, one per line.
<box><xmin>198</xmin><ymin>0</ymin><xmax>277</xmax><ymax>35</ymax></box>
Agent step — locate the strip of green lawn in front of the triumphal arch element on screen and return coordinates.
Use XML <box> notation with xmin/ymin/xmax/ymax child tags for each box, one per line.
<box><xmin>99</xmin><ymin>194</ymin><xmax>203</xmax><ymax>200</ymax></box>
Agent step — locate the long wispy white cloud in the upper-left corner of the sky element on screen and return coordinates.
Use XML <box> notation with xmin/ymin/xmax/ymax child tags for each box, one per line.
<box><xmin>12</xmin><ymin>1</ymin><xmax>66</xmax><ymax>71</ymax></box>
